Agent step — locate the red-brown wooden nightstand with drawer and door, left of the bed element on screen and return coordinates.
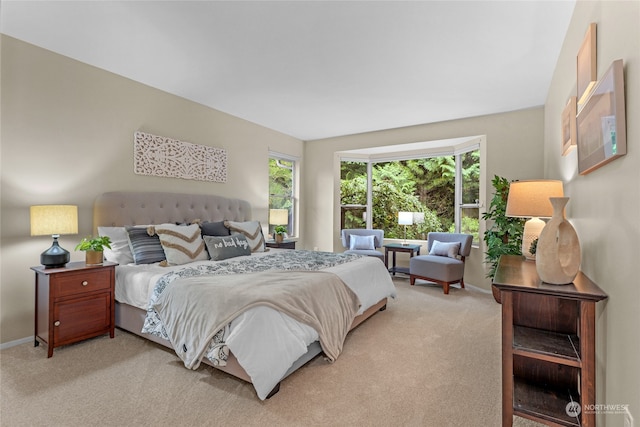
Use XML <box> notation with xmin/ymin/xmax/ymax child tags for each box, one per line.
<box><xmin>31</xmin><ymin>262</ymin><xmax>118</xmax><ymax>357</ymax></box>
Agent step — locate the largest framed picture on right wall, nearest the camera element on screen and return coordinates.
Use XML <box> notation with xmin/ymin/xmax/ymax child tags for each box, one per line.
<box><xmin>577</xmin><ymin>59</ymin><xmax>627</xmax><ymax>175</ymax></box>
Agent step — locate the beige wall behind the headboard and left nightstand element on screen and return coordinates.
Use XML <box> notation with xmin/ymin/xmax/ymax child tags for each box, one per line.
<box><xmin>0</xmin><ymin>36</ymin><xmax>303</xmax><ymax>343</ymax></box>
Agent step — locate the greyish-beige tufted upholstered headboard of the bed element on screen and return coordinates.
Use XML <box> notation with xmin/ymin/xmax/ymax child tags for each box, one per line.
<box><xmin>93</xmin><ymin>192</ymin><xmax>251</xmax><ymax>230</ymax></box>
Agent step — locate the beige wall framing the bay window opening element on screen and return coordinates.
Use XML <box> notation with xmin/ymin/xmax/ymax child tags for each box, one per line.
<box><xmin>302</xmin><ymin>107</ymin><xmax>544</xmax><ymax>290</ymax></box>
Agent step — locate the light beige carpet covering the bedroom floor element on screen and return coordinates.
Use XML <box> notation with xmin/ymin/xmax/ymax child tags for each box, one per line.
<box><xmin>0</xmin><ymin>278</ymin><xmax>535</xmax><ymax>427</ymax></box>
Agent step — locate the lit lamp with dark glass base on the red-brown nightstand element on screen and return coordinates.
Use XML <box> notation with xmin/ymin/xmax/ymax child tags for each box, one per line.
<box><xmin>29</xmin><ymin>205</ymin><xmax>78</xmax><ymax>268</ymax></box>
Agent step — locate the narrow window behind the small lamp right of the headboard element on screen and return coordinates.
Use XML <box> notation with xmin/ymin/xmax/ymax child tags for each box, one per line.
<box><xmin>269</xmin><ymin>153</ymin><xmax>297</xmax><ymax>236</ymax></box>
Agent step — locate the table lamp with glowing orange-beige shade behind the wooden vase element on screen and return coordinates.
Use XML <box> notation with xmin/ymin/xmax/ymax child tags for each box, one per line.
<box><xmin>506</xmin><ymin>179</ymin><xmax>564</xmax><ymax>260</ymax></box>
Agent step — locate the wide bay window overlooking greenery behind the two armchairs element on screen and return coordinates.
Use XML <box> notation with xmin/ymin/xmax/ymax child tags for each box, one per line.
<box><xmin>340</xmin><ymin>144</ymin><xmax>480</xmax><ymax>243</ymax></box>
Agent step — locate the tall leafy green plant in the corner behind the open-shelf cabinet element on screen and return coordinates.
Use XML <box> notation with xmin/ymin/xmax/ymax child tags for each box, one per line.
<box><xmin>482</xmin><ymin>175</ymin><xmax>525</xmax><ymax>303</ymax></box>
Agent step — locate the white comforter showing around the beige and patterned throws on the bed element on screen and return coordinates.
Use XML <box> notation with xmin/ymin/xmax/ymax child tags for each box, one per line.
<box><xmin>116</xmin><ymin>250</ymin><xmax>396</xmax><ymax>399</ymax></box>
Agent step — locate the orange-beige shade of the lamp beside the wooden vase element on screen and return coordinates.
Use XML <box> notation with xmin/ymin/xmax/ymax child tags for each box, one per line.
<box><xmin>506</xmin><ymin>180</ymin><xmax>564</xmax><ymax>218</ymax></box>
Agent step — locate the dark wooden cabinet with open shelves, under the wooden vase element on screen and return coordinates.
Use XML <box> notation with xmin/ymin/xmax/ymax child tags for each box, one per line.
<box><xmin>493</xmin><ymin>255</ymin><xmax>607</xmax><ymax>427</ymax></box>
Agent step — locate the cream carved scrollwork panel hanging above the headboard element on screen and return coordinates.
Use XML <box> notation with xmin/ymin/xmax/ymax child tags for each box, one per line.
<box><xmin>133</xmin><ymin>132</ymin><xmax>227</xmax><ymax>182</ymax></box>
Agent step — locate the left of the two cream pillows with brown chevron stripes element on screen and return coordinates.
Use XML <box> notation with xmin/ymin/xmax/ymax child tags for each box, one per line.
<box><xmin>154</xmin><ymin>224</ymin><xmax>208</xmax><ymax>265</ymax></box>
